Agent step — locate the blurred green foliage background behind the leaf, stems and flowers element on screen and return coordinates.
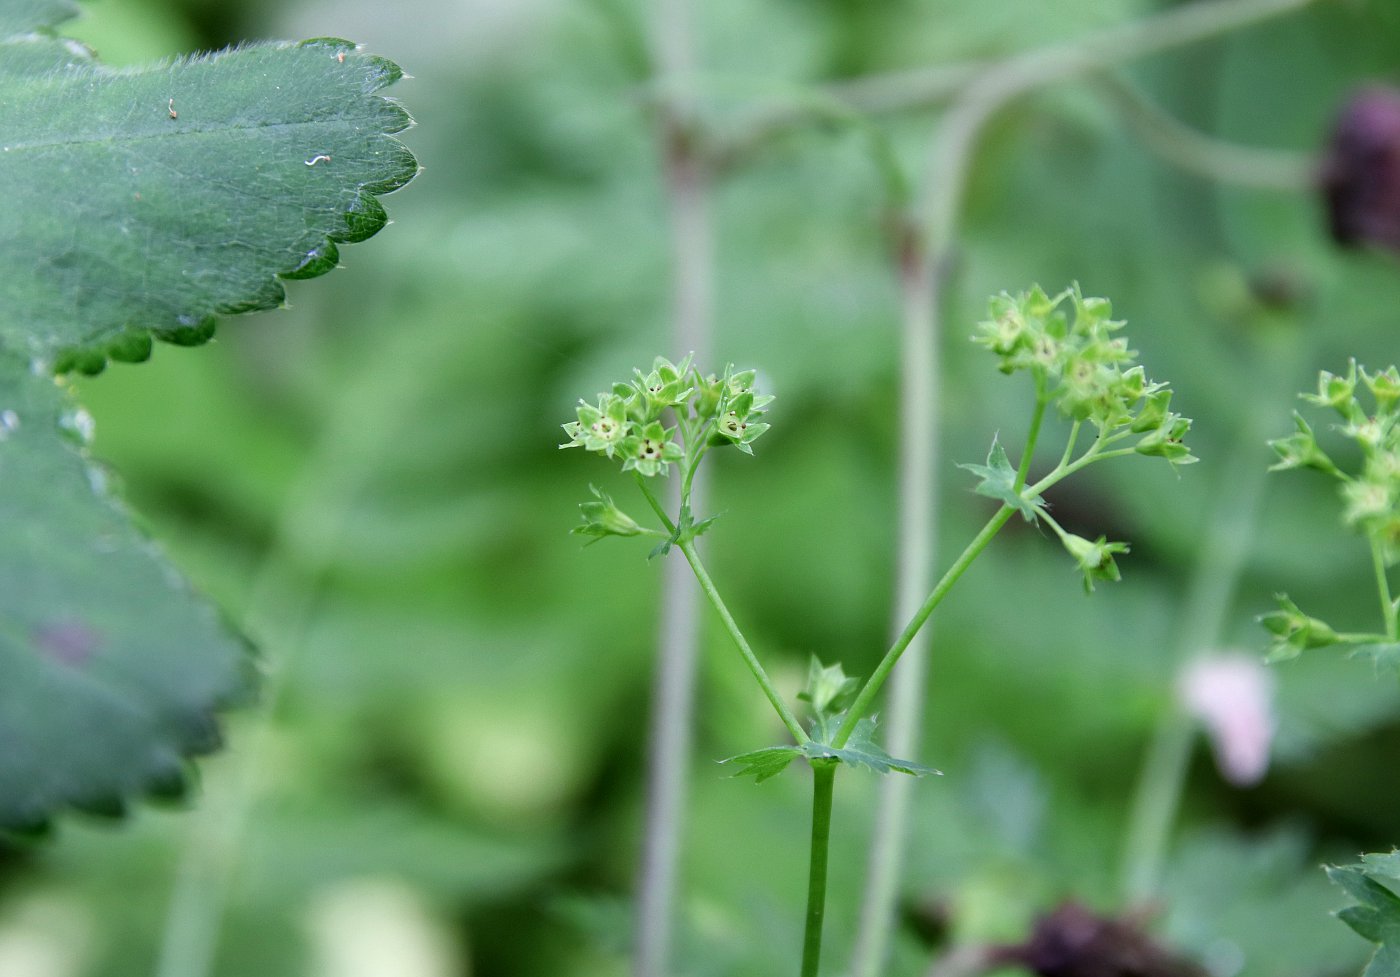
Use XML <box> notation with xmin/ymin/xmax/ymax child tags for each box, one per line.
<box><xmin>0</xmin><ymin>0</ymin><xmax>1400</xmax><ymax>977</ymax></box>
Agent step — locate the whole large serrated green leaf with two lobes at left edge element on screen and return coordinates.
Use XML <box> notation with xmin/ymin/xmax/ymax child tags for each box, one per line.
<box><xmin>0</xmin><ymin>7</ymin><xmax>417</xmax><ymax>830</ymax></box>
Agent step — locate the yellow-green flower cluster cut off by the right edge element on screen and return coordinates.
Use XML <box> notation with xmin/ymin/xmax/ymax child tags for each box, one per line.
<box><xmin>1268</xmin><ymin>360</ymin><xmax>1400</xmax><ymax>565</ymax></box>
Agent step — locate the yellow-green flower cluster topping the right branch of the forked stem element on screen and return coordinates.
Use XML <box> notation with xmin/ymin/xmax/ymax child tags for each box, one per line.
<box><xmin>973</xmin><ymin>286</ymin><xmax>1196</xmax><ymax>463</ymax></box>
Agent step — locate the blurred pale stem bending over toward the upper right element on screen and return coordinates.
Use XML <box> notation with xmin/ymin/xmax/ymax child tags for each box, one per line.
<box><xmin>851</xmin><ymin>0</ymin><xmax>1316</xmax><ymax>977</ymax></box>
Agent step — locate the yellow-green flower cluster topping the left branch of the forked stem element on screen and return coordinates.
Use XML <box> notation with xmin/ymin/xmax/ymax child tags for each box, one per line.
<box><xmin>560</xmin><ymin>357</ymin><xmax>773</xmax><ymax>477</ymax></box>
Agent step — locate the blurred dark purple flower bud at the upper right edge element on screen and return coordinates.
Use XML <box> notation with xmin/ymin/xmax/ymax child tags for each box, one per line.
<box><xmin>1322</xmin><ymin>85</ymin><xmax>1400</xmax><ymax>251</ymax></box>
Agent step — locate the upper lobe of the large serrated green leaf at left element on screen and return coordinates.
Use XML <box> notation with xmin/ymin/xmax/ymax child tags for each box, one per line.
<box><xmin>0</xmin><ymin>36</ymin><xmax>417</xmax><ymax>371</ymax></box>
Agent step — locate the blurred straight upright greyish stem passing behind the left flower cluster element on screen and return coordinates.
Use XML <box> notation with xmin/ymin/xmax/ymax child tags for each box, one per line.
<box><xmin>633</xmin><ymin>0</ymin><xmax>714</xmax><ymax>977</ymax></box>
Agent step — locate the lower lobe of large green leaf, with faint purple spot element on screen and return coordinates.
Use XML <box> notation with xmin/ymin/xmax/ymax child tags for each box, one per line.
<box><xmin>0</xmin><ymin>354</ymin><xmax>251</xmax><ymax>830</ymax></box>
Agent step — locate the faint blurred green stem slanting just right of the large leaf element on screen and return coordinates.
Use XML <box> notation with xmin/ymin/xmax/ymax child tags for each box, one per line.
<box><xmin>153</xmin><ymin>330</ymin><xmax>451</xmax><ymax>977</ymax></box>
